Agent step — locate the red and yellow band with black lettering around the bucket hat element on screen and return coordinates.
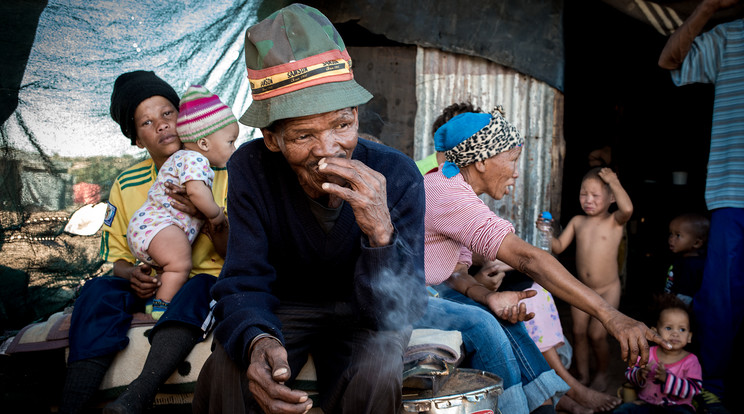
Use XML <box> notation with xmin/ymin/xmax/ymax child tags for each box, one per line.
<box><xmin>248</xmin><ymin>50</ymin><xmax>354</xmax><ymax>100</ymax></box>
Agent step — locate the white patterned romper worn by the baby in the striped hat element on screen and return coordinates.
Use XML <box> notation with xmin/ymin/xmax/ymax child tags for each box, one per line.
<box><xmin>127</xmin><ymin>150</ymin><xmax>214</xmax><ymax>266</ymax></box>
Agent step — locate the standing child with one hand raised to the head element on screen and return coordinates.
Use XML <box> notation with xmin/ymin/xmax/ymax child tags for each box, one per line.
<box><xmin>551</xmin><ymin>167</ymin><xmax>633</xmax><ymax>391</ymax></box>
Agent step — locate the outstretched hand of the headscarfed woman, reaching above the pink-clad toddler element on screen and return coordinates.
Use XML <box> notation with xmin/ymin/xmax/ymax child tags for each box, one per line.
<box><xmin>603</xmin><ymin>309</ymin><xmax>672</xmax><ymax>367</ymax></box>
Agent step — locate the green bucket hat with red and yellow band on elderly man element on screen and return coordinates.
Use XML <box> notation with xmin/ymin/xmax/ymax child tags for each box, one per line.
<box><xmin>240</xmin><ymin>3</ymin><xmax>372</xmax><ymax>128</ymax></box>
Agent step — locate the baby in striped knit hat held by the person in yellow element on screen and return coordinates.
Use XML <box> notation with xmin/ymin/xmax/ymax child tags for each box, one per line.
<box><xmin>127</xmin><ymin>85</ymin><xmax>239</xmax><ymax>319</ymax></box>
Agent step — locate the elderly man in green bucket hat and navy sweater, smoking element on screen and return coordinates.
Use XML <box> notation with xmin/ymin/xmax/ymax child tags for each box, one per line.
<box><xmin>194</xmin><ymin>4</ymin><xmax>426</xmax><ymax>413</ymax></box>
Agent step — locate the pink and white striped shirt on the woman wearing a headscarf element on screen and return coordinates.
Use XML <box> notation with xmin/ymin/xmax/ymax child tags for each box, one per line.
<box><xmin>424</xmin><ymin>169</ymin><xmax>514</xmax><ymax>286</ymax></box>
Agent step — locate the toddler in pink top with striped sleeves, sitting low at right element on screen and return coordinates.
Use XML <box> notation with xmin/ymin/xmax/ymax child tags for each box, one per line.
<box><xmin>614</xmin><ymin>294</ymin><xmax>703</xmax><ymax>414</ymax></box>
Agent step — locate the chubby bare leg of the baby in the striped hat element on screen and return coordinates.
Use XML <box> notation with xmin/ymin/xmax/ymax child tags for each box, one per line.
<box><xmin>147</xmin><ymin>226</ymin><xmax>191</xmax><ymax>302</ymax></box>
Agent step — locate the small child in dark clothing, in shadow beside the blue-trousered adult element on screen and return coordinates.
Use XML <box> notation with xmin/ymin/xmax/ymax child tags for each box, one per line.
<box><xmin>664</xmin><ymin>213</ymin><xmax>710</xmax><ymax>306</ymax></box>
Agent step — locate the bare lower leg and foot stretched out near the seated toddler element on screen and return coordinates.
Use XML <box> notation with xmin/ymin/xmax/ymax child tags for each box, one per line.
<box><xmin>543</xmin><ymin>347</ymin><xmax>621</xmax><ymax>414</ymax></box>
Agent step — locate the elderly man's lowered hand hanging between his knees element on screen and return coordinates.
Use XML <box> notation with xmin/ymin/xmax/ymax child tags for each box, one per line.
<box><xmin>247</xmin><ymin>338</ymin><xmax>313</xmax><ymax>414</ymax></box>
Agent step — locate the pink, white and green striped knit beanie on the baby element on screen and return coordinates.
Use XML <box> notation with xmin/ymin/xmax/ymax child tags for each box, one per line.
<box><xmin>176</xmin><ymin>85</ymin><xmax>238</xmax><ymax>142</ymax></box>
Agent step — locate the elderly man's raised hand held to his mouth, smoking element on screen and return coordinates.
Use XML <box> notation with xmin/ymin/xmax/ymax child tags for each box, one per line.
<box><xmin>318</xmin><ymin>158</ymin><xmax>393</xmax><ymax>247</ymax></box>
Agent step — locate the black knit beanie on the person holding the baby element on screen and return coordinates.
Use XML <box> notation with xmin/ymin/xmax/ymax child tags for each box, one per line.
<box><xmin>111</xmin><ymin>70</ymin><xmax>179</xmax><ymax>145</ymax></box>
